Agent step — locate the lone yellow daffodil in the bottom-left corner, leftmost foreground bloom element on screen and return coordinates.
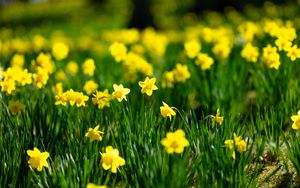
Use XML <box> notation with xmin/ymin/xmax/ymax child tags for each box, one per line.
<box><xmin>27</xmin><ymin>147</ymin><xmax>49</xmax><ymax>171</ymax></box>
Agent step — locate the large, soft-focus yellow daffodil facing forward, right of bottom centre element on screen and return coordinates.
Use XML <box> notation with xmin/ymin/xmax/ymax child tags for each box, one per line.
<box><xmin>160</xmin><ymin>129</ymin><xmax>189</xmax><ymax>154</ymax></box>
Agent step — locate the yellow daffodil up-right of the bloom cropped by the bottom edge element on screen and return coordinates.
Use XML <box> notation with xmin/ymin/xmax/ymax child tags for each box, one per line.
<box><xmin>101</xmin><ymin>146</ymin><xmax>125</xmax><ymax>173</ymax></box>
